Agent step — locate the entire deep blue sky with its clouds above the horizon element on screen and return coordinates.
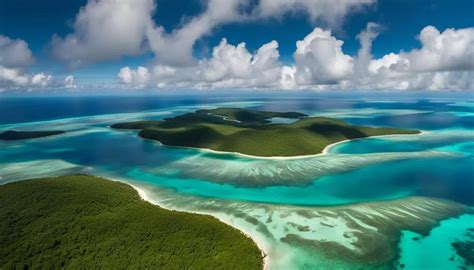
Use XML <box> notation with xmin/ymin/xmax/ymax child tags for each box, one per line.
<box><xmin>0</xmin><ymin>0</ymin><xmax>474</xmax><ymax>93</ymax></box>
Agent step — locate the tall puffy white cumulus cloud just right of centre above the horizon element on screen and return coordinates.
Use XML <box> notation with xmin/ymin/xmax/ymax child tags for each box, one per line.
<box><xmin>293</xmin><ymin>28</ymin><xmax>354</xmax><ymax>85</ymax></box>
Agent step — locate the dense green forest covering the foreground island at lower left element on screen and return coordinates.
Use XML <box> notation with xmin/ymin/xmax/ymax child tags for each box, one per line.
<box><xmin>0</xmin><ymin>175</ymin><xmax>262</xmax><ymax>269</ymax></box>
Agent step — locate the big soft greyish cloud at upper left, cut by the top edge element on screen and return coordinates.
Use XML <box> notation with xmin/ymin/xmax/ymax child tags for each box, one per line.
<box><xmin>51</xmin><ymin>0</ymin><xmax>155</xmax><ymax>66</ymax></box>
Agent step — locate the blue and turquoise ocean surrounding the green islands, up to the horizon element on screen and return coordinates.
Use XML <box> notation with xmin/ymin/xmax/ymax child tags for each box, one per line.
<box><xmin>0</xmin><ymin>93</ymin><xmax>474</xmax><ymax>269</ymax></box>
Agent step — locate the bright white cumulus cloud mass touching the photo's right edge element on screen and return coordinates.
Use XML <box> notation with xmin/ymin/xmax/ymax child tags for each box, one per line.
<box><xmin>351</xmin><ymin>26</ymin><xmax>474</xmax><ymax>90</ymax></box>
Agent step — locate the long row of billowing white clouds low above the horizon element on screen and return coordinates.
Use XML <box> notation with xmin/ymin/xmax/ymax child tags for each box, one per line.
<box><xmin>118</xmin><ymin>23</ymin><xmax>474</xmax><ymax>90</ymax></box>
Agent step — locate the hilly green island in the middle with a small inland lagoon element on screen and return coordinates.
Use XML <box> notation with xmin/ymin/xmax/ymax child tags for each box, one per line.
<box><xmin>111</xmin><ymin>108</ymin><xmax>420</xmax><ymax>157</ymax></box>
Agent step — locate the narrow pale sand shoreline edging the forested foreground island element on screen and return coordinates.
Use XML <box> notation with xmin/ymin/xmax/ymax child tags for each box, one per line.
<box><xmin>130</xmin><ymin>182</ymin><xmax>270</xmax><ymax>270</ymax></box>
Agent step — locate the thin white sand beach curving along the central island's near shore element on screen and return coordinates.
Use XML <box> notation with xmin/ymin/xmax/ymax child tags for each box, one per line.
<box><xmin>144</xmin><ymin>130</ymin><xmax>428</xmax><ymax>160</ymax></box>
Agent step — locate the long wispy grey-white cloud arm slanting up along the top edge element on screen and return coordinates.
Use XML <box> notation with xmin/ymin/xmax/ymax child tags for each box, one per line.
<box><xmin>147</xmin><ymin>0</ymin><xmax>375</xmax><ymax>65</ymax></box>
